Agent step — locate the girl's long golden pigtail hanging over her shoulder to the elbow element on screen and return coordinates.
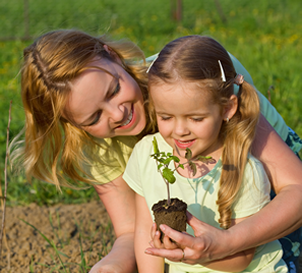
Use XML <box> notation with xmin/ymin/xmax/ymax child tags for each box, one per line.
<box><xmin>217</xmin><ymin>81</ymin><xmax>260</xmax><ymax>229</ymax></box>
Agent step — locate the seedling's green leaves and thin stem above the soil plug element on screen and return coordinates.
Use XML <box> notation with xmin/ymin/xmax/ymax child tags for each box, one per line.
<box><xmin>151</xmin><ymin>137</ymin><xmax>212</xmax><ymax>206</ymax></box>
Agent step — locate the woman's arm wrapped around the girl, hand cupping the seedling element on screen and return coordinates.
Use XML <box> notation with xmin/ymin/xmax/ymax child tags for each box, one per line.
<box><xmin>148</xmin><ymin>116</ymin><xmax>302</xmax><ymax>264</ymax></box>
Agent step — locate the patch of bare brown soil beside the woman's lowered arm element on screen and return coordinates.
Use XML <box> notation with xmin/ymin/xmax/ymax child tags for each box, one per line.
<box><xmin>0</xmin><ymin>201</ymin><xmax>115</xmax><ymax>273</ymax></box>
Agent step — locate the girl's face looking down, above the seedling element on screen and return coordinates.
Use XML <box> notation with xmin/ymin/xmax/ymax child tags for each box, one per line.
<box><xmin>150</xmin><ymin>81</ymin><xmax>228</xmax><ymax>159</ymax></box>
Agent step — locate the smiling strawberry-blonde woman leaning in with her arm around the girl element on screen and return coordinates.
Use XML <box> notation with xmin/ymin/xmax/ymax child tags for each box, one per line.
<box><xmin>16</xmin><ymin>30</ymin><xmax>302</xmax><ymax>273</ymax></box>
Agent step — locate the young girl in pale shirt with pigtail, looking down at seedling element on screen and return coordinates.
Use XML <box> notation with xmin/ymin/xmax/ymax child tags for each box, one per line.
<box><xmin>123</xmin><ymin>36</ymin><xmax>287</xmax><ymax>273</ymax></box>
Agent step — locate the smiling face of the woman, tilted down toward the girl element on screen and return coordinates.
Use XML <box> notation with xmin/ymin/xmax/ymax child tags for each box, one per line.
<box><xmin>66</xmin><ymin>59</ymin><xmax>146</xmax><ymax>138</ymax></box>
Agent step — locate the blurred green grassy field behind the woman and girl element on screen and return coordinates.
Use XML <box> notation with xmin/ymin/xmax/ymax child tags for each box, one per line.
<box><xmin>0</xmin><ymin>0</ymin><xmax>302</xmax><ymax>205</ymax></box>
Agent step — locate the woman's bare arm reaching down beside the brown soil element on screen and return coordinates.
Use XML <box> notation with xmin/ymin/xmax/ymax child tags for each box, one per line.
<box><xmin>90</xmin><ymin>176</ymin><xmax>137</xmax><ymax>273</ymax></box>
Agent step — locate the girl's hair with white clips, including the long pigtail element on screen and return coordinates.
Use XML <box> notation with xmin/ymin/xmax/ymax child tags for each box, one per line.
<box><xmin>148</xmin><ymin>35</ymin><xmax>260</xmax><ymax>228</ymax></box>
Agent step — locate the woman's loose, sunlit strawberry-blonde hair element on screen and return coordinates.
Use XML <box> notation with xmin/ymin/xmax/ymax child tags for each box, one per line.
<box><xmin>17</xmin><ymin>30</ymin><xmax>147</xmax><ymax>187</ymax></box>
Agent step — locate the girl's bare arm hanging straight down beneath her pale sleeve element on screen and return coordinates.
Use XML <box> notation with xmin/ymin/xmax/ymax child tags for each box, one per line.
<box><xmin>134</xmin><ymin>194</ymin><xmax>164</xmax><ymax>273</ymax></box>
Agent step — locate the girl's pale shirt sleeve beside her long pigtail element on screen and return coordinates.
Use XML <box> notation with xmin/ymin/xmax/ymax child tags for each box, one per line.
<box><xmin>232</xmin><ymin>156</ymin><xmax>271</xmax><ymax>219</ymax></box>
